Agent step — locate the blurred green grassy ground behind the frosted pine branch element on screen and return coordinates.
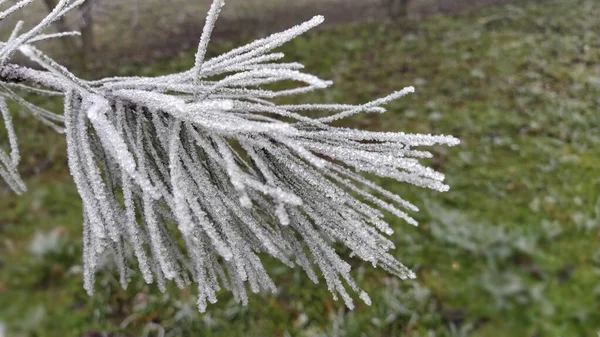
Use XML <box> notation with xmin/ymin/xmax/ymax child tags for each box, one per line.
<box><xmin>0</xmin><ymin>0</ymin><xmax>600</xmax><ymax>337</ymax></box>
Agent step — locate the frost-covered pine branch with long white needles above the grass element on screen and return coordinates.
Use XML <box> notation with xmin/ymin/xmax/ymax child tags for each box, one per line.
<box><xmin>0</xmin><ymin>0</ymin><xmax>459</xmax><ymax>311</ymax></box>
